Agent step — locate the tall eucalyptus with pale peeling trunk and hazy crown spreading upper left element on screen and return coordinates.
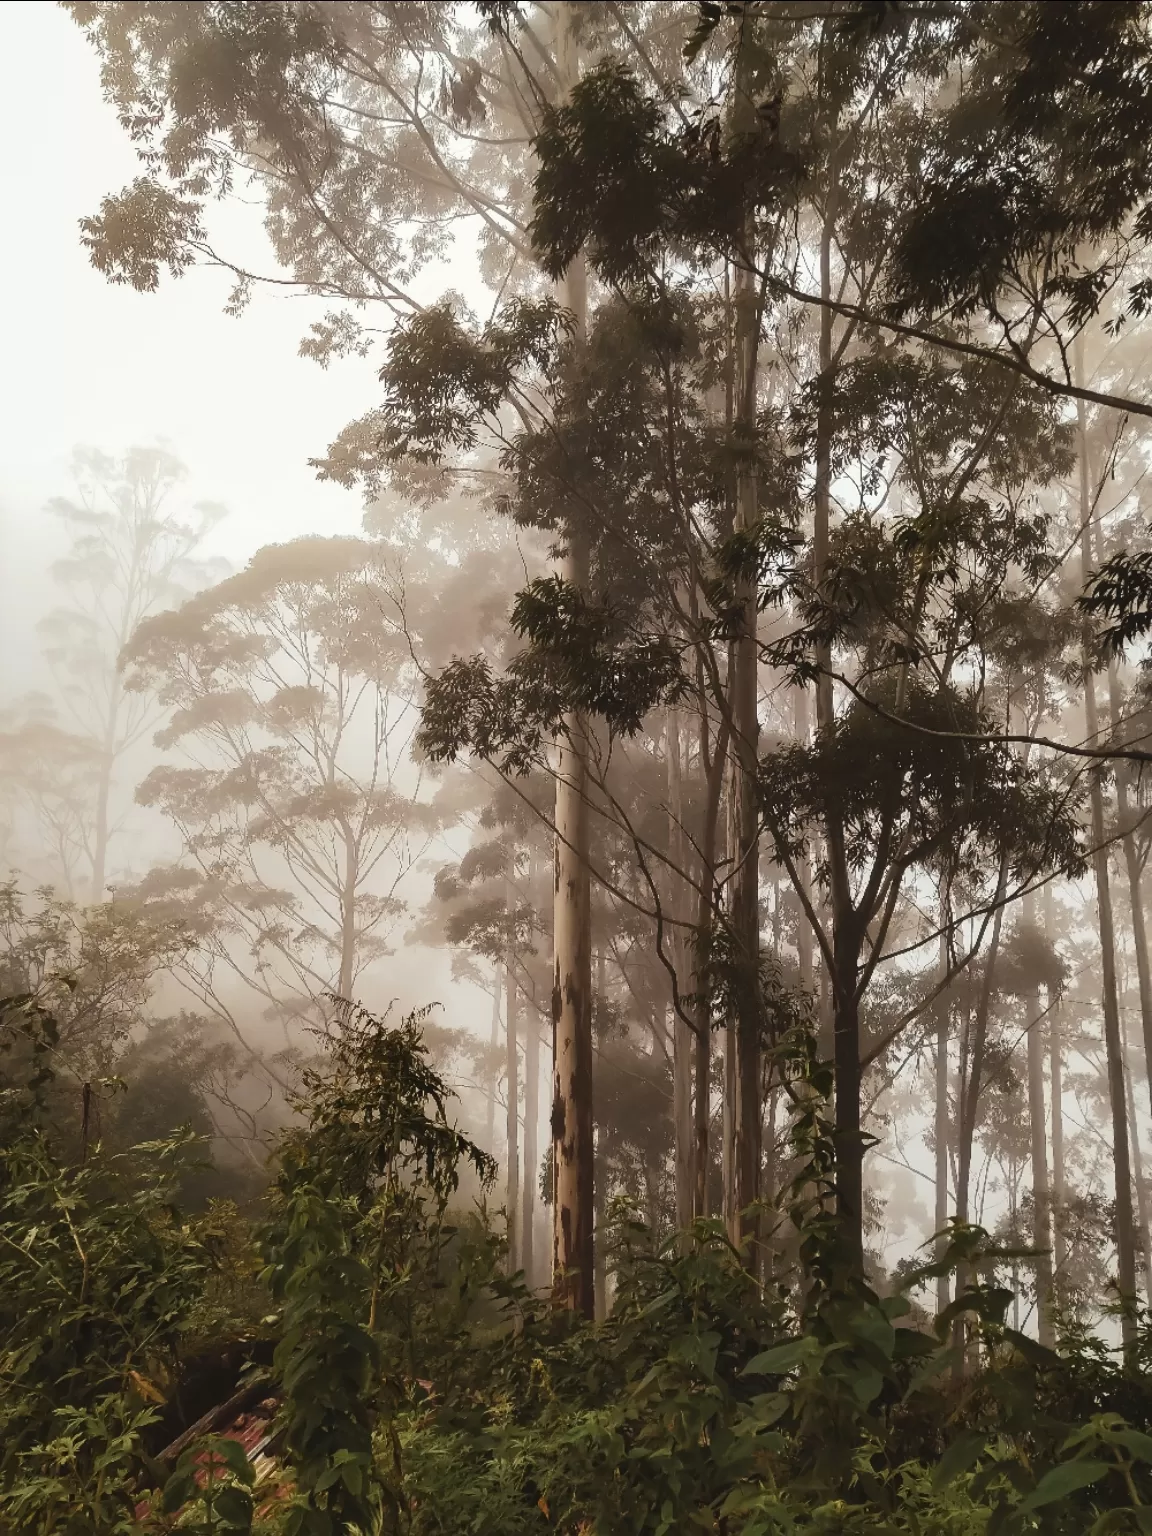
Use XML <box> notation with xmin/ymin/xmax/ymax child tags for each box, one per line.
<box><xmin>68</xmin><ymin>0</ymin><xmax>703</xmax><ymax>1310</ymax></box>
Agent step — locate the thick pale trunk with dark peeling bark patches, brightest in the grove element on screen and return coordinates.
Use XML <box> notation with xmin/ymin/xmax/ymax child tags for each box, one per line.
<box><xmin>551</xmin><ymin>6</ymin><xmax>596</xmax><ymax>1318</ymax></box>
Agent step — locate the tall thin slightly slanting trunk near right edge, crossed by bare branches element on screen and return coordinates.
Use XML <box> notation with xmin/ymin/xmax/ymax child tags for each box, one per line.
<box><xmin>1077</xmin><ymin>380</ymin><xmax>1137</xmax><ymax>1355</ymax></box>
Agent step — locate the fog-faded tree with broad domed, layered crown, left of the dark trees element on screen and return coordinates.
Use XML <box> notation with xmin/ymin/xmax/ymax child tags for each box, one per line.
<box><xmin>124</xmin><ymin>538</ymin><xmax>439</xmax><ymax>1050</ymax></box>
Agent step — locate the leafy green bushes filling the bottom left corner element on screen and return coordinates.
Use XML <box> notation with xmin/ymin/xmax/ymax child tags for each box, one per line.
<box><xmin>0</xmin><ymin>998</ymin><xmax>218</xmax><ymax>1536</ymax></box>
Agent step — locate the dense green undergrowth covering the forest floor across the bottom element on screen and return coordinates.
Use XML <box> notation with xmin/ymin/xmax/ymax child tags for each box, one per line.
<box><xmin>0</xmin><ymin>1005</ymin><xmax>1152</xmax><ymax>1536</ymax></box>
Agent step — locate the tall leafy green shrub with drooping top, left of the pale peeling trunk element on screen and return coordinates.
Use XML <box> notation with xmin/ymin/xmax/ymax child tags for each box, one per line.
<box><xmin>264</xmin><ymin>1003</ymin><xmax>495</xmax><ymax>1536</ymax></box>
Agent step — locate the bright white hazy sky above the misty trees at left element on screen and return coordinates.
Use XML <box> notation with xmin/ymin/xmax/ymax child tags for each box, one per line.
<box><xmin>0</xmin><ymin>0</ymin><xmax>385</xmax><ymax>675</ymax></box>
